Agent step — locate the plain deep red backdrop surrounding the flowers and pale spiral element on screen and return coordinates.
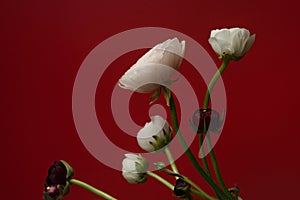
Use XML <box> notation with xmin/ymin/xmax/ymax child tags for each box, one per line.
<box><xmin>0</xmin><ymin>0</ymin><xmax>300</xmax><ymax>199</ymax></box>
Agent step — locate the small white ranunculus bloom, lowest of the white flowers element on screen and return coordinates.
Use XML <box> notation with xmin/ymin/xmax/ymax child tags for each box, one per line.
<box><xmin>122</xmin><ymin>153</ymin><xmax>148</xmax><ymax>183</ymax></box>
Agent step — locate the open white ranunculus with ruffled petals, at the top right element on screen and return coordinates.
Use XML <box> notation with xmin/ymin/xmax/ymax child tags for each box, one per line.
<box><xmin>208</xmin><ymin>28</ymin><xmax>255</xmax><ymax>60</ymax></box>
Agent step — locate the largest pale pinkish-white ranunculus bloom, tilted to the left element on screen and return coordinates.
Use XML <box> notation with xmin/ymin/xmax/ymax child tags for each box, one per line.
<box><xmin>119</xmin><ymin>38</ymin><xmax>185</xmax><ymax>93</ymax></box>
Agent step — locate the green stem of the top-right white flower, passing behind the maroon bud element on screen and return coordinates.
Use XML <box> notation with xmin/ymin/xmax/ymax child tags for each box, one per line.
<box><xmin>203</xmin><ymin>59</ymin><xmax>232</xmax><ymax>199</ymax></box>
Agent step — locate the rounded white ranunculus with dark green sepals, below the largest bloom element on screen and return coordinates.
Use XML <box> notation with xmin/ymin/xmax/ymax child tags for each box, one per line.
<box><xmin>137</xmin><ymin>115</ymin><xmax>172</xmax><ymax>152</ymax></box>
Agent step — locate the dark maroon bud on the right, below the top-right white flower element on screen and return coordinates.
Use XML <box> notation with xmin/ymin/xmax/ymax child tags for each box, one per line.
<box><xmin>193</xmin><ymin>108</ymin><xmax>222</xmax><ymax>133</ymax></box>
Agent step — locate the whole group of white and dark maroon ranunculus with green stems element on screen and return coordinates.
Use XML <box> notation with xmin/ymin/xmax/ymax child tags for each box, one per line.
<box><xmin>44</xmin><ymin>28</ymin><xmax>255</xmax><ymax>200</ymax></box>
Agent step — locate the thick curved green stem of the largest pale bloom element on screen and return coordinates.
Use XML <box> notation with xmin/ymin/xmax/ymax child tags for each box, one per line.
<box><xmin>169</xmin><ymin>94</ymin><xmax>228</xmax><ymax>200</ymax></box>
